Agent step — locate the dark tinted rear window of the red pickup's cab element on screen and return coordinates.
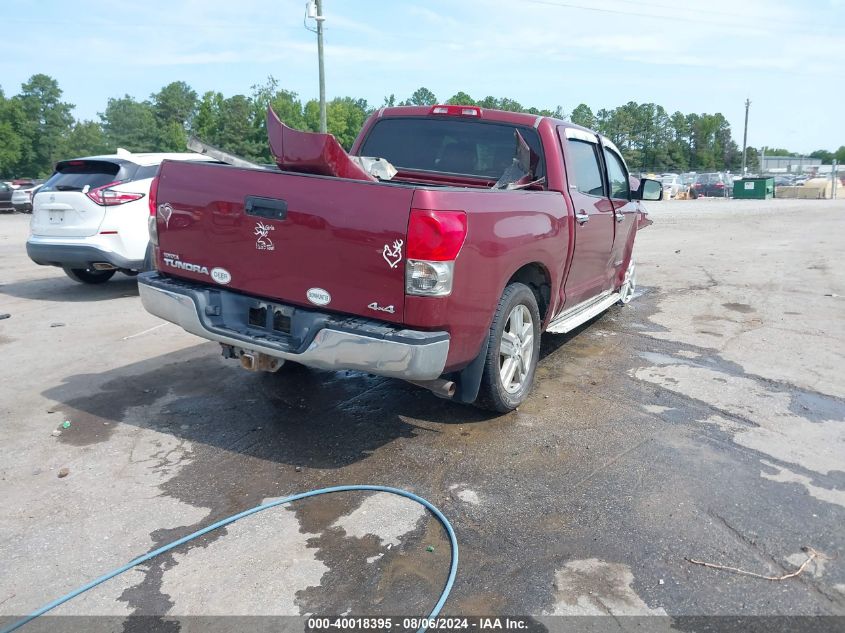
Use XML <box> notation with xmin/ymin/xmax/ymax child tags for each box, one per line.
<box><xmin>359</xmin><ymin>117</ymin><xmax>543</xmax><ymax>180</ymax></box>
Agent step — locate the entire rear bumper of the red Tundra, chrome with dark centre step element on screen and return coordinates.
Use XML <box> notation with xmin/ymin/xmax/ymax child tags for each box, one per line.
<box><xmin>138</xmin><ymin>273</ymin><xmax>449</xmax><ymax>380</ymax></box>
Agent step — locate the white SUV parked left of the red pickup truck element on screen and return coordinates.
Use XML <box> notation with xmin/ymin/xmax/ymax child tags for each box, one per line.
<box><xmin>26</xmin><ymin>149</ymin><xmax>209</xmax><ymax>284</ymax></box>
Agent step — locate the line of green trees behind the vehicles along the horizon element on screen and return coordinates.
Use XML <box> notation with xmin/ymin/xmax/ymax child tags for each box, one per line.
<box><xmin>0</xmin><ymin>74</ymin><xmax>845</xmax><ymax>178</ymax></box>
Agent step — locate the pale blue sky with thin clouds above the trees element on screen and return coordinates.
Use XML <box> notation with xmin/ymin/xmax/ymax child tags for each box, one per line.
<box><xmin>0</xmin><ymin>0</ymin><xmax>845</xmax><ymax>153</ymax></box>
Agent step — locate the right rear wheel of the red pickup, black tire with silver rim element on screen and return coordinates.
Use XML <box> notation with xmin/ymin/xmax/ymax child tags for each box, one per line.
<box><xmin>475</xmin><ymin>283</ymin><xmax>540</xmax><ymax>413</ymax></box>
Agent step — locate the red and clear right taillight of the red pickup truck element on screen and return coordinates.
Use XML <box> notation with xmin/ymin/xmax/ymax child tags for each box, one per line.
<box><xmin>405</xmin><ymin>209</ymin><xmax>467</xmax><ymax>297</ymax></box>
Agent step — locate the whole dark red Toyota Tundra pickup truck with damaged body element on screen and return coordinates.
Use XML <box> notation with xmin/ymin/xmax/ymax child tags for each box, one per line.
<box><xmin>139</xmin><ymin>105</ymin><xmax>662</xmax><ymax>412</ymax></box>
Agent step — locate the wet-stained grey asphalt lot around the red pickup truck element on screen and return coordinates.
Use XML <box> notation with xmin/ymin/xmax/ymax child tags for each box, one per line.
<box><xmin>0</xmin><ymin>200</ymin><xmax>845</xmax><ymax>630</ymax></box>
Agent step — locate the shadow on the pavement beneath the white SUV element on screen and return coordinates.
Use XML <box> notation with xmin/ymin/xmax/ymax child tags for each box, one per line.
<box><xmin>0</xmin><ymin>273</ymin><xmax>138</xmax><ymax>302</ymax></box>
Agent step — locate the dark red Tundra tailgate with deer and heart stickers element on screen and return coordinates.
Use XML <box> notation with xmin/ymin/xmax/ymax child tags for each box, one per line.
<box><xmin>156</xmin><ymin>161</ymin><xmax>414</xmax><ymax>323</ymax></box>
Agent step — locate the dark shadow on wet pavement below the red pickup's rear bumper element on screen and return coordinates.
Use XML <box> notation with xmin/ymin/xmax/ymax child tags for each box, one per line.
<box><xmin>43</xmin><ymin>344</ymin><xmax>496</xmax><ymax>469</ymax></box>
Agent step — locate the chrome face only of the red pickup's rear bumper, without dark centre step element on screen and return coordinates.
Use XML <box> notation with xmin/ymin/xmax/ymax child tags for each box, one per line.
<box><xmin>138</xmin><ymin>273</ymin><xmax>449</xmax><ymax>380</ymax></box>
